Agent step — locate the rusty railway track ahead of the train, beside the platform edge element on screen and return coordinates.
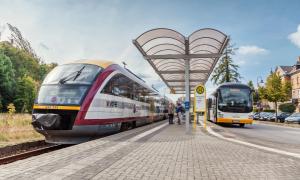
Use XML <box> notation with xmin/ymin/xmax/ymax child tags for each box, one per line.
<box><xmin>0</xmin><ymin>144</ymin><xmax>70</xmax><ymax>165</ymax></box>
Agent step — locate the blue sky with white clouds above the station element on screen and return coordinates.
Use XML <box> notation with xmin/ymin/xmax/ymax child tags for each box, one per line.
<box><xmin>0</xmin><ymin>0</ymin><xmax>300</xmax><ymax>98</ymax></box>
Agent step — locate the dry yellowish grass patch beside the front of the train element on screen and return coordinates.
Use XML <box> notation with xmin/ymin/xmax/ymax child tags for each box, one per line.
<box><xmin>0</xmin><ymin>113</ymin><xmax>43</xmax><ymax>147</ymax></box>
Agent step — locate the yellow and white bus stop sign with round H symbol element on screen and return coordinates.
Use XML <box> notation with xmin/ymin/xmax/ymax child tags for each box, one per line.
<box><xmin>194</xmin><ymin>84</ymin><xmax>206</xmax><ymax>112</ymax></box>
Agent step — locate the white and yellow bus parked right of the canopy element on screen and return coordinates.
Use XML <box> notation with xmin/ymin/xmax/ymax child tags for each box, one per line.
<box><xmin>208</xmin><ymin>83</ymin><xmax>253</xmax><ymax>127</ymax></box>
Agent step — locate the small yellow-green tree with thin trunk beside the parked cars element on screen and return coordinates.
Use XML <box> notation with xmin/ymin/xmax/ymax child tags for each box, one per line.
<box><xmin>259</xmin><ymin>72</ymin><xmax>288</xmax><ymax>121</ymax></box>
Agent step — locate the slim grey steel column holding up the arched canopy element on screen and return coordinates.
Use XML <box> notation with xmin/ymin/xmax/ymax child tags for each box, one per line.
<box><xmin>185</xmin><ymin>59</ymin><xmax>190</xmax><ymax>133</ymax></box>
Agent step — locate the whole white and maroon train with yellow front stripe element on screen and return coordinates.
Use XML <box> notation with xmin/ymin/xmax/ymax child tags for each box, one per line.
<box><xmin>32</xmin><ymin>60</ymin><xmax>168</xmax><ymax>144</ymax></box>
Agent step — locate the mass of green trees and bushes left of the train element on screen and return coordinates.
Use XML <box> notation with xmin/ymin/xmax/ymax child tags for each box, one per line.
<box><xmin>0</xmin><ymin>42</ymin><xmax>57</xmax><ymax>112</ymax></box>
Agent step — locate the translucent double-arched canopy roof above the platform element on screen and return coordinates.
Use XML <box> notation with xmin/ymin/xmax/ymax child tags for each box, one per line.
<box><xmin>133</xmin><ymin>28</ymin><xmax>229</xmax><ymax>94</ymax></box>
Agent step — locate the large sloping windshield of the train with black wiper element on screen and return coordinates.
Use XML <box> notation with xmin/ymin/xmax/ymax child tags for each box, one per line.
<box><xmin>36</xmin><ymin>64</ymin><xmax>101</xmax><ymax>105</ymax></box>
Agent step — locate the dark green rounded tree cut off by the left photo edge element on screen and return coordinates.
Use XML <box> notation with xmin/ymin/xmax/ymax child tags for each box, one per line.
<box><xmin>0</xmin><ymin>50</ymin><xmax>15</xmax><ymax>111</ymax></box>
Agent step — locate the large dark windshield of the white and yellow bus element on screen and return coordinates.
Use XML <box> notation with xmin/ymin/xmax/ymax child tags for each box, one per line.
<box><xmin>218</xmin><ymin>87</ymin><xmax>253</xmax><ymax>113</ymax></box>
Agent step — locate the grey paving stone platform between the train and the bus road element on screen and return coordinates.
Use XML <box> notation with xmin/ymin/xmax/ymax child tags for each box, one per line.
<box><xmin>0</xmin><ymin>122</ymin><xmax>300</xmax><ymax>180</ymax></box>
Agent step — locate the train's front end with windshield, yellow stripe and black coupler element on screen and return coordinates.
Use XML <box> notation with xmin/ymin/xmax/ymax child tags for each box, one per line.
<box><xmin>32</xmin><ymin>63</ymin><xmax>102</xmax><ymax>144</ymax></box>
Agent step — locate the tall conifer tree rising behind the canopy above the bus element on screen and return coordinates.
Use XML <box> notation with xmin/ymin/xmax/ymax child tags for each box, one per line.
<box><xmin>211</xmin><ymin>45</ymin><xmax>242</xmax><ymax>85</ymax></box>
